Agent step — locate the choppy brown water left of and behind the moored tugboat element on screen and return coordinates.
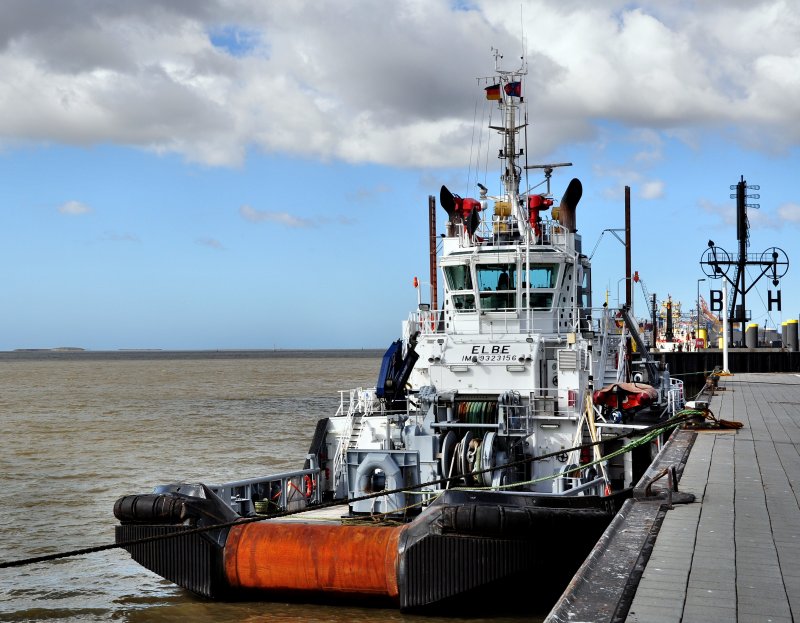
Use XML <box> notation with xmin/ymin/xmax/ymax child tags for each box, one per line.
<box><xmin>0</xmin><ymin>352</ymin><xmax>530</xmax><ymax>623</ymax></box>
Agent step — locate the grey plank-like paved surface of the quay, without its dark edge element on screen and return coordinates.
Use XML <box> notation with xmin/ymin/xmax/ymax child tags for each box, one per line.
<box><xmin>627</xmin><ymin>374</ymin><xmax>800</xmax><ymax>623</ymax></box>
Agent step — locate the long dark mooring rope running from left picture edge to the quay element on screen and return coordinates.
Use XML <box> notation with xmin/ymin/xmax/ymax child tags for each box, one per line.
<box><xmin>0</xmin><ymin>409</ymin><xmax>705</xmax><ymax>569</ymax></box>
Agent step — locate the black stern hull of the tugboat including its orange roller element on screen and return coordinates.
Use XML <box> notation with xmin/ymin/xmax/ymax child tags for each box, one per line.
<box><xmin>117</xmin><ymin>491</ymin><xmax>627</xmax><ymax>610</ymax></box>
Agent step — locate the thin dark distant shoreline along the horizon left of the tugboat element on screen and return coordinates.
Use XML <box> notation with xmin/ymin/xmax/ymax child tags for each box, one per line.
<box><xmin>0</xmin><ymin>348</ymin><xmax>384</xmax><ymax>361</ymax></box>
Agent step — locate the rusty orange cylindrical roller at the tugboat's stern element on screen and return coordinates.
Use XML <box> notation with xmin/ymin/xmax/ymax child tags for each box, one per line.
<box><xmin>224</xmin><ymin>522</ymin><xmax>403</xmax><ymax>598</ymax></box>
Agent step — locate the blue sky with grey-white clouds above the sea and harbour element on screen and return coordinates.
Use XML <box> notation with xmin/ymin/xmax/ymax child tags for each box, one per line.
<box><xmin>0</xmin><ymin>0</ymin><xmax>800</xmax><ymax>350</ymax></box>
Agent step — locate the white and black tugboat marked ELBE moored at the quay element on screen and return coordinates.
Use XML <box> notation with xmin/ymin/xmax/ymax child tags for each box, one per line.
<box><xmin>114</xmin><ymin>54</ymin><xmax>682</xmax><ymax>610</ymax></box>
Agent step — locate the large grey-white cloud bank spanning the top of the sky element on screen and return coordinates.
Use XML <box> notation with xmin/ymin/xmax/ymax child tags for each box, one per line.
<box><xmin>0</xmin><ymin>0</ymin><xmax>800</xmax><ymax>166</ymax></box>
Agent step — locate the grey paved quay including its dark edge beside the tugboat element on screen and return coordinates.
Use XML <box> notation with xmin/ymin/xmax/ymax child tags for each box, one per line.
<box><xmin>546</xmin><ymin>374</ymin><xmax>800</xmax><ymax>623</ymax></box>
